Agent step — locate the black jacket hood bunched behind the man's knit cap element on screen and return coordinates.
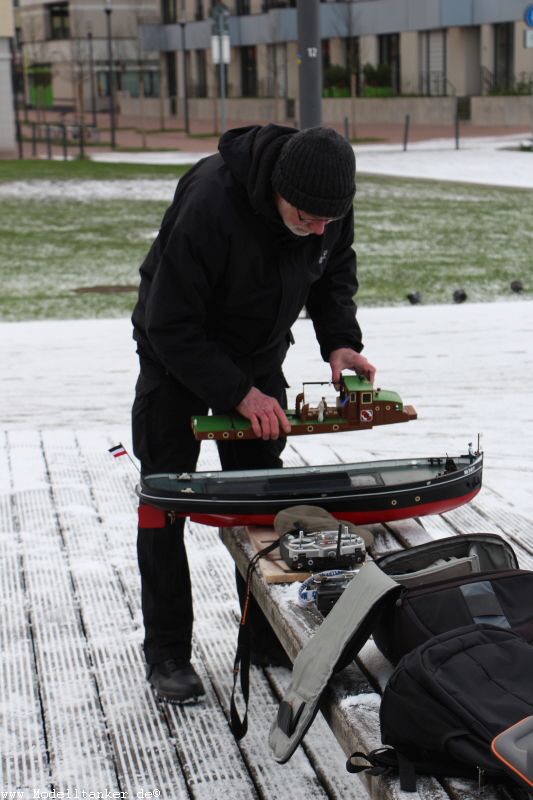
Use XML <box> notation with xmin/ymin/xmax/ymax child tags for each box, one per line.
<box><xmin>218</xmin><ymin>124</ymin><xmax>298</xmax><ymax>224</ymax></box>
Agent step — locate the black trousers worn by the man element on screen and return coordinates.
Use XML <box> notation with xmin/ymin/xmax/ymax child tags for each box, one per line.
<box><xmin>132</xmin><ymin>359</ymin><xmax>286</xmax><ymax>664</ymax></box>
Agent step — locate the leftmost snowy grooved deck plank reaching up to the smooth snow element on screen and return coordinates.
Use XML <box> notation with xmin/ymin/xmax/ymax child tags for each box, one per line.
<box><xmin>8</xmin><ymin>432</ymin><xmax>119</xmax><ymax>791</ymax></box>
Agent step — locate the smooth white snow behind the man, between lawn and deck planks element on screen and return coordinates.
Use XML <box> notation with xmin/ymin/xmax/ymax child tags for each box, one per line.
<box><xmin>0</xmin><ymin>300</ymin><xmax>533</xmax><ymax>513</ymax></box>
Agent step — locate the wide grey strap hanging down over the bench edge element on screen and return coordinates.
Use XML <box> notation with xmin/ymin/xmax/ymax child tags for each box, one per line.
<box><xmin>269</xmin><ymin>561</ymin><xmax>401</xmax><ymax>764</ymax></box>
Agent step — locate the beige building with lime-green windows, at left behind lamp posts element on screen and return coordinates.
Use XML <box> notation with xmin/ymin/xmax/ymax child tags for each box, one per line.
<box><xmin>17</xmin><ymin>0</ymin><xmax>161</xmax><ymax>120</ymax></box>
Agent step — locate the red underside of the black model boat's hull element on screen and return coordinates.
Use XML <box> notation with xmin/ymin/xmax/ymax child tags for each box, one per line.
<box><xmin>187</xmin><ymin>489</ymin><xmax>479</xmax><ymax>528</ymax></box>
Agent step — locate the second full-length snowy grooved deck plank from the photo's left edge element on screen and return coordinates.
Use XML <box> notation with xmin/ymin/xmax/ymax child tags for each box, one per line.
<box><xmin>43</xmin><ymin>431</ymin><xmax>190</xmax><ymax>798</ymax></box>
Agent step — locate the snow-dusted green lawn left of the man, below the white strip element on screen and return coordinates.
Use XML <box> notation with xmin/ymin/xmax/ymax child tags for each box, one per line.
<box><xmin>0</xmin><ymin>195</ymin><xmax>166</xmax><ymax>320</ymax></box>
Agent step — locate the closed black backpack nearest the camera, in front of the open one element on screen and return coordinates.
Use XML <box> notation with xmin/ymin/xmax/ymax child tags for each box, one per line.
<box><xmin>347</xmin><ymin>625</ymin><xmax>533</xmax><ymax>792</ymax></box>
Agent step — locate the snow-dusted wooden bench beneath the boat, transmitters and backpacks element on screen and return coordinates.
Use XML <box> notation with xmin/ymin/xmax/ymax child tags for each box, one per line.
<box><xmin>220</xmin><ymin>518</ymin><xmax>511</xmax><ymax>800</ymax></box>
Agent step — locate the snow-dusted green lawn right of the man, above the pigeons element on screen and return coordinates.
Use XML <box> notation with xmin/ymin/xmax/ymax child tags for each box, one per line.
<box><xmin>356</xmin><ymin>176</ymin><xmax>533</xmax><ymax>306</ymax></box>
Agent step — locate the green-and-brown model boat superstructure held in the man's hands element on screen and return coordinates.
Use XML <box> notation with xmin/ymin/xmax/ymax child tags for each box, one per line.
<box><xmin>191</xmin><ymin>375</ymin><xmax>417</xmax><ymax>439</ymax></box>
